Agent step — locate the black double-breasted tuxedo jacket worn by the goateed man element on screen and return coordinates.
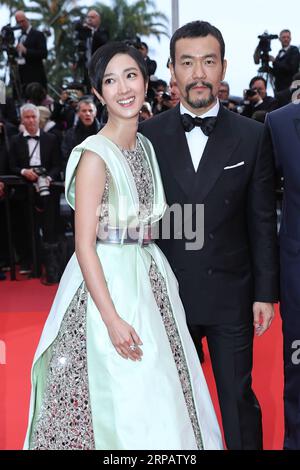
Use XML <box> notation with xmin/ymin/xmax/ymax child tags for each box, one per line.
<box><xmin>141</xmin><ymin>105</ymin><xmax>278</xmax><ymax>325</ymax></box>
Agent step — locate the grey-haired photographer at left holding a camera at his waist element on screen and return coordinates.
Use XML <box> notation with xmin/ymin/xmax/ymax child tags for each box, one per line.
<box><xmin>9</xmin><ymin>103</ymin><xmax>61</xmax><ymax>283</ymax></box>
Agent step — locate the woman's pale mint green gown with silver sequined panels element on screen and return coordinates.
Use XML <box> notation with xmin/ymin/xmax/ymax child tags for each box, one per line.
<box><xmin>24</xmin><ymin>134</ymin><xmax>222</xmax><ymax>450</ymax></box>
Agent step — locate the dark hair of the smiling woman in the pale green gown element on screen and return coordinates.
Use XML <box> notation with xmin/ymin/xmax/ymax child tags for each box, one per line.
<box><xmin>89</xmin><ymin>42</ymin><xmax>148</xmax><ymax>95</ymax></box>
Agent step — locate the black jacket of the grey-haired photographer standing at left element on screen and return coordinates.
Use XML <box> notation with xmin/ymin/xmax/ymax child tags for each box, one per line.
<box><xmin>9</xmin><ymin>131</ymin><xmax>61</xmax><ymax>180</ymax></box>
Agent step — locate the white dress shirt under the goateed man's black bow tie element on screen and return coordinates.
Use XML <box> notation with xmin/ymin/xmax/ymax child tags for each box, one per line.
<box><xmin>180</xmin><ymin>100</ymin><xmax>220</xmax><ymax>171</ymax></box>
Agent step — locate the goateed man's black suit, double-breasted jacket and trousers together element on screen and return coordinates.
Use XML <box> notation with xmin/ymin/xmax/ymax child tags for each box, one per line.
<box><xmin>141</xmin><ymin>105</ymin><xmax>278</xmax><ymax>449</ymax></box>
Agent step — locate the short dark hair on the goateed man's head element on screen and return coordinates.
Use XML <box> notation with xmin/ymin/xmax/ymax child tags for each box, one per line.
<box><xmin>170</xmin><ymin>21</ymin><xmax>225</xmax><ymax>65</ymax></box>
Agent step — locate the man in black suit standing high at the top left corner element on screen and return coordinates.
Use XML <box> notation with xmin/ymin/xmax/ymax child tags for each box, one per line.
<box><xmin>15</xmin><ymin>11</ymin><xmax>47</xmax><ymax>97</ymax></box>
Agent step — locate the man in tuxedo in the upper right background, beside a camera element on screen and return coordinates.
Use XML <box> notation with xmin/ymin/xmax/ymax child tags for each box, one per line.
<box><xmin>269</xmin><ymin>29</ymin><xmax>300</xmax><ymax>93</ymax></box>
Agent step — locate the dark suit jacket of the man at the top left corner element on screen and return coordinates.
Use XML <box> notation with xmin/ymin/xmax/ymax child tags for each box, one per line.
<box><xmin>19</xmin><ymin>28</ymin><xmax>47</xmax><ymax>88</ymax></box>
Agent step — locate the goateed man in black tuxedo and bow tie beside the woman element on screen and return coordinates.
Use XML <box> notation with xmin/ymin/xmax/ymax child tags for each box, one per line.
<box><xmin>141</xmin><ymin>21</ymin><xmax>278</xmax><ymax>449</ymax></box>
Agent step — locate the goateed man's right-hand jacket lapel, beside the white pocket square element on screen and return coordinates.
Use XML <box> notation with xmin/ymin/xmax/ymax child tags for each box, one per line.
<box><xmin>192</xmin><ymin>106</ymin><xmax>240</xmax><ymax>203</ymax></box>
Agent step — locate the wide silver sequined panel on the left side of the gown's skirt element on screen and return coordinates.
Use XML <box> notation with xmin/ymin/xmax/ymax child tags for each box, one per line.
<box><xmin>30</xmin><ymin>284</ymin><xmax>95</xmax><ymax>450</ymax></box>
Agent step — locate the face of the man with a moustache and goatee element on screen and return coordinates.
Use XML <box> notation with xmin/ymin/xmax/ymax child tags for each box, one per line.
<box><xmin>170</xmin><ymin>34</ymin><xmax>226</xmax><ymax>114</ymax></box>
